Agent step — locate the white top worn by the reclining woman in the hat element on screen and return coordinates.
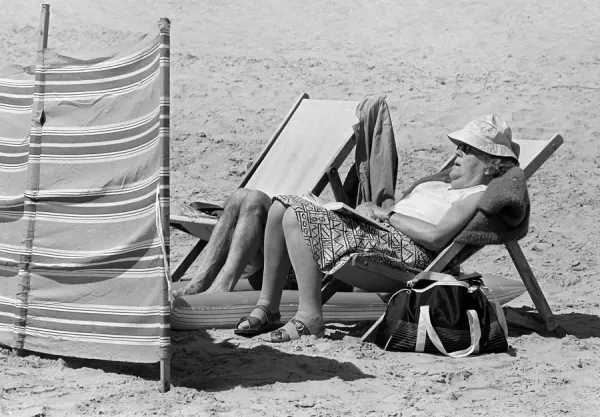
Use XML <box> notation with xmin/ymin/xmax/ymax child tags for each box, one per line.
<box><xmin>394</xmin><ymin>181</ymin><xmax>487</xmax><ymax>224</ymax></box>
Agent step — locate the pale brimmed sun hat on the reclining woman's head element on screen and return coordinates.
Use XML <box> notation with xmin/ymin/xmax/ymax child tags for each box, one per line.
<box><xmin>448</xmin><ymin>114</ymin><xmax>519</xmax><ymax>163</ymax></box>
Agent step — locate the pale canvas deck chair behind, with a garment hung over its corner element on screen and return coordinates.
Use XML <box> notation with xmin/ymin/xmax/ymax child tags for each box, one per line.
<box><xmin>170</xmin><ymin>94</ymin><xmax>358</xmax><ymax>282</ymax></box>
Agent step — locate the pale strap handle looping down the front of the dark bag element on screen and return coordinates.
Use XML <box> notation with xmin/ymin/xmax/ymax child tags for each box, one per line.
<box><xmin>415</xmin><ymin>306</ymin><xmax>481</xmax><ymax>358</ymax></box>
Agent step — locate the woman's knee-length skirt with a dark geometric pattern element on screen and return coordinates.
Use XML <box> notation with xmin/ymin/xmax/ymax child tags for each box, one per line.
<box><xmin>273</xmin><ymin>195</ymin><xmax>436</xmax><ymax>274</ymax></box>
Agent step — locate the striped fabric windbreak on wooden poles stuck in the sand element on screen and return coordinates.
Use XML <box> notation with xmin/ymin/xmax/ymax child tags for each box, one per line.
<box><xmin>0</xmin><ymin>8</ymin><xmax>170</xmax><ymax>391</ymax></box>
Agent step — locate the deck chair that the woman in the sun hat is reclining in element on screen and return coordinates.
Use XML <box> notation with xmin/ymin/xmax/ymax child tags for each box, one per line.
<box><xmin>322</xmin><ymin>134</ymin><xmax>563</xmax><ymax>341</ymax></box>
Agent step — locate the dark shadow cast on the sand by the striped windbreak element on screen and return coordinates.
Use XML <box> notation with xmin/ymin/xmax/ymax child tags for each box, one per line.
<box><xmin>17</xmin><ymin>330</ymin><xmax>373</xmax><ymax>391</ymax></box>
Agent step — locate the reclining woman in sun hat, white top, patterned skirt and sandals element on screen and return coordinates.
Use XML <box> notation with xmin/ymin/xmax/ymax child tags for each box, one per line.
<box><xmin>235</xmin><ymin>115</ymin><xmax>518</xmax><ymax>343</ymax></box>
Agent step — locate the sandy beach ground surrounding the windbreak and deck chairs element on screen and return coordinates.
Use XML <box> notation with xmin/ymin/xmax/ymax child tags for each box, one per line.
<box><xmin>0</xmin><ymin>0</ymin><xmax>600</xmax><ymax>417</ymax></box>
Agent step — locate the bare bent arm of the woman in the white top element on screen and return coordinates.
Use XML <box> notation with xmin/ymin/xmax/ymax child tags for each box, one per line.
<box><xmin>380</xmin><ymin>192</ymin><xmax>483</xmax><ymax>252</ymax></box>
